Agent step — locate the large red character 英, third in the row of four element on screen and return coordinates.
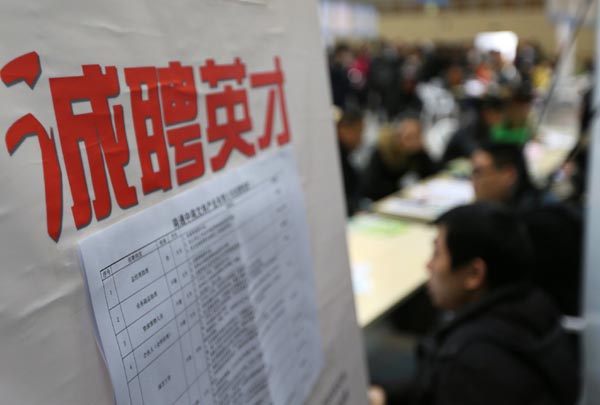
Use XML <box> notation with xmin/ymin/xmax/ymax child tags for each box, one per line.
<box><xmin>200</xmin><ymin>58</ymin><xmax>256</xmax><ymax>171</ymax></box>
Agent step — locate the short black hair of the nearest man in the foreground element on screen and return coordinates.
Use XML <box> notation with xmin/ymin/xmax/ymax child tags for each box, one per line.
<box><xmin>435</xmin><ymin>202</ymin><xmax>533</xmax><ymax>289</ymax></box>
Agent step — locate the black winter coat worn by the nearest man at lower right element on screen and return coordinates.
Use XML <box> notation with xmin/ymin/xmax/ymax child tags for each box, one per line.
<box><xmin>415</xmin><ymin>285</ymin><xmax>579</xmax><ymax>405</ymax></box>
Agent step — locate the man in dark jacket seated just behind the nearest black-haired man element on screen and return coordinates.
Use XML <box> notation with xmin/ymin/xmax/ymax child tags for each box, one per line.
<box><xmin>471</xmin><ymin>143</ymin><xmax>583</xmax><ymax>315</ymax></box>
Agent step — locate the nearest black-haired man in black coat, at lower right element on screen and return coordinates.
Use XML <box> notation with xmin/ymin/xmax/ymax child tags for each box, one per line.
<box><xmin>415</xmin><ymin>203</ymin><xmax>579</xmax><ymax>405</ymax></box>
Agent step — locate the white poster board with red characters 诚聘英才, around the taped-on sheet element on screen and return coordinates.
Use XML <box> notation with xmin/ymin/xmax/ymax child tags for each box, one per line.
<box><xmin>0</xmin><ymin>0</ymin><xmax>367</xmax><ymax>405</ymax></box>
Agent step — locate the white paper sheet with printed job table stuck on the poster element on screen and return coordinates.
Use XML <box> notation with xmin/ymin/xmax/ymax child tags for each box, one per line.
<box><xmin>80</xmin><ymin>148</ymin><xmax>323</xmax><ymax>405</ymax></box>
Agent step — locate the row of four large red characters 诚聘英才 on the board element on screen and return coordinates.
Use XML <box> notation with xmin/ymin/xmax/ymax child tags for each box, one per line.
<box><xmin>0</xmin><ymin>52</ymin><xmax>290</xmax><ymax>241</ymax></box>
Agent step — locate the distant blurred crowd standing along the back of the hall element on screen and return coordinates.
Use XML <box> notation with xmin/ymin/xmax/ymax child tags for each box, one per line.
<box><xmin>329</xmin><ymin>41</ymin><xmax>554</xmax><ymax>120</ymax></box>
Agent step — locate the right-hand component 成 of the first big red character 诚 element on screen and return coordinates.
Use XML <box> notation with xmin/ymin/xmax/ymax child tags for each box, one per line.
<box><xmin>50</xmin><ymin>65</ymin><xmax>138</xmax><ymax>228</ymax></box>
